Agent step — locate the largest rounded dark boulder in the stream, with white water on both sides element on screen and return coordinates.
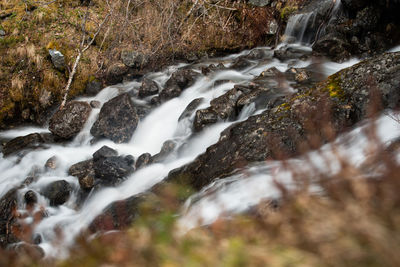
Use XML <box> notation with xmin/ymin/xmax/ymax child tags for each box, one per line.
<box><xmin>90</xmin><ymin>93</ymin><xmax>139</xmax><ymax>143</ymax></box>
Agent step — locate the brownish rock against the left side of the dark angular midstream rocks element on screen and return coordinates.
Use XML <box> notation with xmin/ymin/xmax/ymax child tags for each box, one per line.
<box><xmin>68</xmin><ymin>159</ymin><xmax>95</xmax><ymax>190</ymax></box>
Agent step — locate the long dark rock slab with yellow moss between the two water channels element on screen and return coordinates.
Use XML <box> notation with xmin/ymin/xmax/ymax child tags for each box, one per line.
<box><xmin>168</xmin><ymin>52</ymin><xmax>400</xmax><ymax>192</ymax></box>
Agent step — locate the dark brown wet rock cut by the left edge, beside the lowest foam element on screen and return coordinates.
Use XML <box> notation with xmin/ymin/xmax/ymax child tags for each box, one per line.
<box><xmin>0</xmin><ymin>189</ymin><xmax>19</xmax><ymax>249</ymax></box>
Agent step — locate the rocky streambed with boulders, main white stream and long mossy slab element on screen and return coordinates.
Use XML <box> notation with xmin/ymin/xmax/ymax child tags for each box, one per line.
<box><xmin>0</xmin><ymin>0</ymin><xmax>400</xmax><ymax>257</ymax></box>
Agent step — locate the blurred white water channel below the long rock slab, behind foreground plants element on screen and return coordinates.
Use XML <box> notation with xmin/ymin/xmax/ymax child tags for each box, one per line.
<box><xmin>179</xmin><ymin>112</ymin><xmax>400</xmax><ymax>233</ymax></box>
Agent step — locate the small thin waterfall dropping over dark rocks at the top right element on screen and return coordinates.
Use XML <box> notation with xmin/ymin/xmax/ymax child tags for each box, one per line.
<box><xmin>284</xmin><ymin>0</ymin><xmax>341</xmax><ymax>44</ymax></box>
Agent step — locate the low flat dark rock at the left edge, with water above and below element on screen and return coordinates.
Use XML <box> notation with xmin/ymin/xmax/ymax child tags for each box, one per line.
<box><xmin>2</xmin><ymin>133</ymin><xmax>45</xmax><ymax>157</ymax></box>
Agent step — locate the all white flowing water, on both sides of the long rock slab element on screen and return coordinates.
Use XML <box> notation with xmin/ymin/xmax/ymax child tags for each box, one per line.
<box><xmin>0</xmin><ymin>0</ymin><xmax>399</xmax><ymax>257</ymax></box>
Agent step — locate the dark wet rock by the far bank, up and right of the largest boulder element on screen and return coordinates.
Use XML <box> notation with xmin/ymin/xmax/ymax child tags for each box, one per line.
<box><xmin>159</xmin><ymin>69</ymin><xmax>199</xmax><ymax>101</ymax></box>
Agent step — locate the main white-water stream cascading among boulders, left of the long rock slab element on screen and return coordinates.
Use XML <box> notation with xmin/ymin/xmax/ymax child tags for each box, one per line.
<box><xmin>0</xmin><ymin>45</ymin><xmax>340</xmax><ymax>257</ymax></box>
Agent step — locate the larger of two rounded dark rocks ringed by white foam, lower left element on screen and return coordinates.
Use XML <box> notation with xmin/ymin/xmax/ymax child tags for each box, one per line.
<box><xmin>42</xmin><ymin>180</ymin><xmax>72</xmax><ymax>206</ymax></box>
